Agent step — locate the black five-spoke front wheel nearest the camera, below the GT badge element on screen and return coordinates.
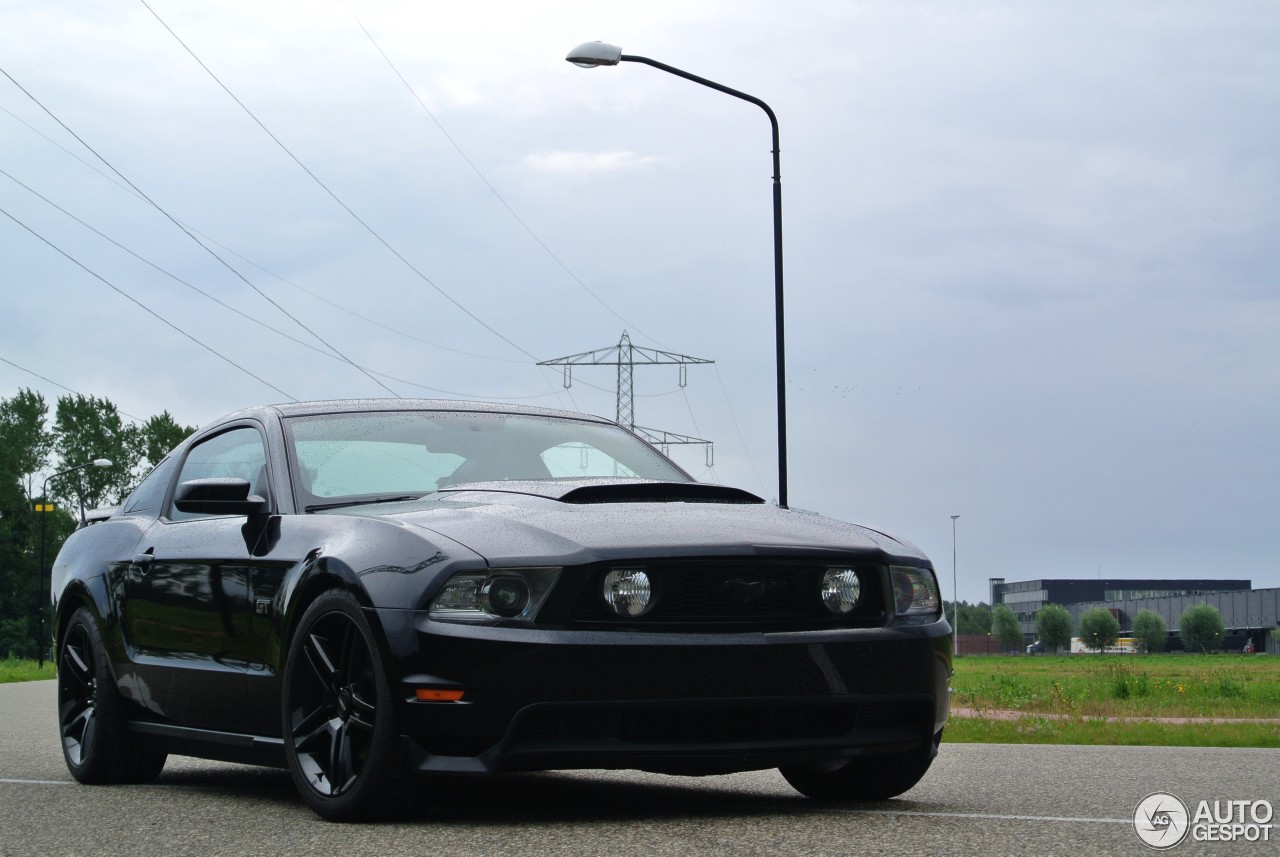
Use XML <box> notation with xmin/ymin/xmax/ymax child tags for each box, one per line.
<box><xmin>282</xmin><ymin>591</ymin><xmax>406</xmax><ymax>821</ymax></box>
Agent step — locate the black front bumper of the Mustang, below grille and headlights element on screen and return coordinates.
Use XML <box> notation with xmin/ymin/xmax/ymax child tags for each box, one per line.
<box><xmin>371</xmin><ymin>610</ymin><xmax>951</xmax><ymax>774</ymax></box>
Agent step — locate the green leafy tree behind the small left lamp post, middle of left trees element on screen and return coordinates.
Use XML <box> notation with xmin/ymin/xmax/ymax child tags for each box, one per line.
<box><xmin>49</xmin><ymin>393</ymin><xmax>142</xmax><ymax>509</ymax></box>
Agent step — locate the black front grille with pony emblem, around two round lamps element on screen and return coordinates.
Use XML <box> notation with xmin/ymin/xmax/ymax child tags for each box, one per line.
<box><xmin>572</xmin><ymin>559</ymin><xmax>884</xmax><ymax>629</ymax></box>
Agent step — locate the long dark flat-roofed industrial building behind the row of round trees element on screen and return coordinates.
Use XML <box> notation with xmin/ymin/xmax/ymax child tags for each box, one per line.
<box><xmin>991</xmin><ymin>577</ymin><xmax>1280</xmax><ymax>652</ymax></box>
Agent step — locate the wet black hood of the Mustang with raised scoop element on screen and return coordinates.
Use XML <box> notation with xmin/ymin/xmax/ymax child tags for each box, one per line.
<box><xmin>339</xmin><ymin>480</ymin><xmax>927</xmax><ymax>567</ymax></box>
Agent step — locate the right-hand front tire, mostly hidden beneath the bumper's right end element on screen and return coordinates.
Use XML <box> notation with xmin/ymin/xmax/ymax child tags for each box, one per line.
<box><xmin>778</xmin><ymin>732</ymin><xmax>942</xmax><ymax>802</ymax></box>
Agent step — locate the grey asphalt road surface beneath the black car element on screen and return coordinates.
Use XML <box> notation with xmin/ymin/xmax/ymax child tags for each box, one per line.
<box><xmin>0</xmin><ymin>682</ymin><xmax>1280</xmax><ymax>857</ymax></box>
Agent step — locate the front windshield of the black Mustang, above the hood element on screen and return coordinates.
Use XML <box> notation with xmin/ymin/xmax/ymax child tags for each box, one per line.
<box><xmin>285</xmin><ymin>411</ymin><xmax>691</xmax><ymax>508</ymax></box>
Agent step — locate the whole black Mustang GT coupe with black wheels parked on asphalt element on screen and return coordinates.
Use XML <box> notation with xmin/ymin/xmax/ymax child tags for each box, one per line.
<box><xmin>52</xmin><ymin>399</ymin><xmax>951</xmax><ymax>820</ymax></box>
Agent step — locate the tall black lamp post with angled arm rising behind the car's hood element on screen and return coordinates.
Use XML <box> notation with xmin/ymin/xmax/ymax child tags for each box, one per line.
<box><xmin>564</xmin><ymin>42</ymin><xmax>787</xmax><ymax>509</ymax></box>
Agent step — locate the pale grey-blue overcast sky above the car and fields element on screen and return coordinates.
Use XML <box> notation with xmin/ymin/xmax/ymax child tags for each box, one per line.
<box><xmin>0</xmin><ymin>0</ymin><xmax>1280</xmax><ymax>601</ymax></box>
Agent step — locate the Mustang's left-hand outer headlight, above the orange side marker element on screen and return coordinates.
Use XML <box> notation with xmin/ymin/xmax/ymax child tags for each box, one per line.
<box><xmin>430</xmin><ymin>568</ymin><xmax>559</xmax><ymax>623</ymax></box>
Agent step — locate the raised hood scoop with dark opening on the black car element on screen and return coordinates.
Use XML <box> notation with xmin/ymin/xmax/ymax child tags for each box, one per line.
<box><xmin>439</xmin><ymin>478</ymin><xmax>764</xmax><ymax>505</ymax></box>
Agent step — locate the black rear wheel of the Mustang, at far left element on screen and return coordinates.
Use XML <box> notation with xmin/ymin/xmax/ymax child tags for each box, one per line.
<box><xmin>58</xmin><ymin>608</ymin><xmax>165</xmax><ymax>785</ymax></box>
